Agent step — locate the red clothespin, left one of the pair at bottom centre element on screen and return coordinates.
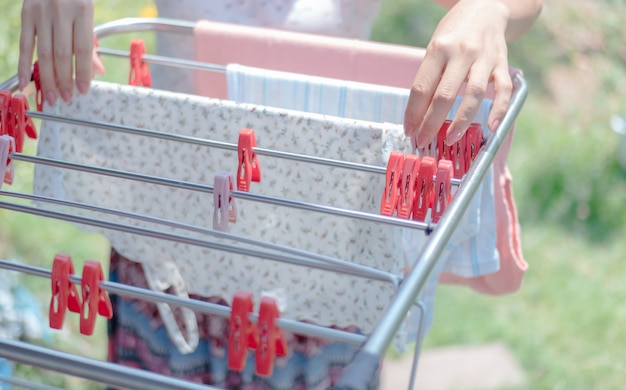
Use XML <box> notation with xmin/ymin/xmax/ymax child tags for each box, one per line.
<box><xmin>228</xmin><ymin>290</ymin><xmax>257</xmax><ymax>372</ymax></box>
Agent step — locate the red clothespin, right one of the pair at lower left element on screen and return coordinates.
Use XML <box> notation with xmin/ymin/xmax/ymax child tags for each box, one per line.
<box><xmin>80</xmin><ymin>260</ymin><xmax>113</xmax><ymax>336</ymax></box>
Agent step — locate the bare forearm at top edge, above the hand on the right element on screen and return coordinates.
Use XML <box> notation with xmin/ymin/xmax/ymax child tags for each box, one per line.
<box><xmin>434</xmin><ymin>0</ymin><xmax>543</xmax><ymax>41</ymax></box>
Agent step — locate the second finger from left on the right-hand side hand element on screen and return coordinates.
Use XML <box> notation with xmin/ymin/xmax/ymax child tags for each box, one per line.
<box><xmin>417</xmin><ymin>64</ymin><xmax>469</xmax><ymax>147</ymax></box>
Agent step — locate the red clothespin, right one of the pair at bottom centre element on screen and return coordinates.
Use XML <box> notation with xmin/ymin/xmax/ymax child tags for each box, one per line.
<box><xmin>255</xmin><ymin>296</ymin><xmax>287</xmax><ymax>377</ymax></box>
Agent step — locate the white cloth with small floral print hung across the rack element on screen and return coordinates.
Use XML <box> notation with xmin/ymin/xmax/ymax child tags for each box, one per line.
<box><xmin>34</xmin><ymin>82</ymin><xmax>410</xmax><ymax>350</ymax></box>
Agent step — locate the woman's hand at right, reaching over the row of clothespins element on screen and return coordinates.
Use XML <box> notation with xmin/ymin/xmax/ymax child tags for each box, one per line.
<box><xmin>404</xmin><ymin>0</ymin><xmax>522</xmax><ymax>147</ymax></box>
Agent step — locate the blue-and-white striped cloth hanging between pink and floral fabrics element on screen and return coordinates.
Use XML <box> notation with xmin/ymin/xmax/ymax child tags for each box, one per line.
<box><xmin>226</xmin><ymin>64</ymin><xmax>500</xmax><ymax>278</ymax></box>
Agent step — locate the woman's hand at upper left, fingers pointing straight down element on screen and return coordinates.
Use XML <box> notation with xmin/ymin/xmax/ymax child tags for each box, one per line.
<box><xmin>18</xmin><ymin>0</ymin><xmax>96</xmax><ymax>104</ymax></box>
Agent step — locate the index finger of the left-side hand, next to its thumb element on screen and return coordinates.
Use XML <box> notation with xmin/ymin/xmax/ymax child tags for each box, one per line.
<box><xmin>74</xmin><ymin>1</ymin><xmax>94</xmax><ymax>94</ymax></box>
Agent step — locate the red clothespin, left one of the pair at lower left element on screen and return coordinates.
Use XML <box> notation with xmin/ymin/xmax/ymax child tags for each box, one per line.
<box><xmin>49</xmin><ymin>254</ymin><xmax>80</xmax><ymax>329</ymax></box>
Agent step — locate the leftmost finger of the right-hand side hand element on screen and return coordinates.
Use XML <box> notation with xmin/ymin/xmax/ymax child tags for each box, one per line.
<box><xmin>404</xmin><ymin>54</ymin><xmax>444</xmax><ymax>137</ymax></box>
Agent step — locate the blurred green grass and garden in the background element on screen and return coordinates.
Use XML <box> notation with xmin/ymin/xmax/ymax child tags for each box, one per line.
<box><xmin>0</xmin><ymin>0</ymin><xmax>626</xmax><ymax>389</ymax></box>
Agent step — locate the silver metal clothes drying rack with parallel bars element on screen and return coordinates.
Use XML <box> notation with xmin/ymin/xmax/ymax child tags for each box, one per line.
<box><xmin>0</xmin><ymin>18</ymin><xmax>528</xmax><ymax>389</ymax></box>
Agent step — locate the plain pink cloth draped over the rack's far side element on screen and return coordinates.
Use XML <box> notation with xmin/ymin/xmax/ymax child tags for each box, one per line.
<box><xmin>194</xmin><ymin>21</ymin><xmax>528</xmax><ymax>294</ymax></box>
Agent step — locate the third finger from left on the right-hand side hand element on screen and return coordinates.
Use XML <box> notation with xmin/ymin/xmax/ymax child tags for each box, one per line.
<box><xmin>446</xmin><ymin>63</ymin><xmax>492</xmax><ymax>145</ymax></box>
